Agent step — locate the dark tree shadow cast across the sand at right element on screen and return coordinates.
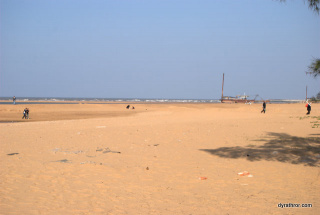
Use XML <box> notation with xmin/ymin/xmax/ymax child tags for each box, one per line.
<box><xmin>200</xmin><ymin>132</ymin><xmax>320</xmax><ymax>167</ymax></box>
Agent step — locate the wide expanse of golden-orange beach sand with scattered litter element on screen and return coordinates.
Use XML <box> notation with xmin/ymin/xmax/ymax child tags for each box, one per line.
<box><xmin>0</xmin><ymin>103</ymin><xmax>320</xmax><ymax>215</ymax></box>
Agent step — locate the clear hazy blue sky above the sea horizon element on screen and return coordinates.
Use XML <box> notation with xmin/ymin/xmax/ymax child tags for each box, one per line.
<box><xmin>0</xmin><ymin>0</ymin><xmax>320</xmax><ymax>99</ymax></box>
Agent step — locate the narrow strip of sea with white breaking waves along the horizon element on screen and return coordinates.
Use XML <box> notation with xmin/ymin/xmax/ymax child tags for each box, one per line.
<box><xmin>0</xmin><ymin>97</ymin><xmax>305</xmax><ymax>104</ymax></box>
